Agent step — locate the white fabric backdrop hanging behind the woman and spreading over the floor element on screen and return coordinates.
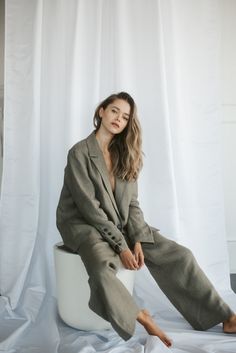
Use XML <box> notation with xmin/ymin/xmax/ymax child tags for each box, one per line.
<box><xmin>0</xmin><ymin>0</ymin><xmax>236</xmax><ymax>353</ymax></box>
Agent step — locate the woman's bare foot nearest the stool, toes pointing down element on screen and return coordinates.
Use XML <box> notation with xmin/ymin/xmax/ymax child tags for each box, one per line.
<box><xmin>137</xmin><ymin>309</ymin><xmax>172</xmax><ymax>347</ymax></box>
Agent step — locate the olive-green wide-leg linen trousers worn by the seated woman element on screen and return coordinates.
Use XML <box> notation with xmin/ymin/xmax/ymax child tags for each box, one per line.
<box><xmin>78</xmin><ymin>230</ymin><xmax>233</xmax><ymax>340</ymax></box>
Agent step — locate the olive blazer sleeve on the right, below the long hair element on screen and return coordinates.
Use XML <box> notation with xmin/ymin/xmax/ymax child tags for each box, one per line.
<box><xmin>126</xmin><ymin>181</ymin><xmax>154</xmax><ymax>244</ymax></box>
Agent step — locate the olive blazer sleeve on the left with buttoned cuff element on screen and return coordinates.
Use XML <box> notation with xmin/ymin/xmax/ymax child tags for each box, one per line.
<box><xmin>65</xmin><ymin>146</ymin><xmax>128</xmax><ymax>254</ymax></box>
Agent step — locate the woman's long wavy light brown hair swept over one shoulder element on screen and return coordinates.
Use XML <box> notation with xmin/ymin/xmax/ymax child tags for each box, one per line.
<box><xmin>93</xmin><ymin>92</ymin><xmax>143</xmax><ymax>181</ymax></box>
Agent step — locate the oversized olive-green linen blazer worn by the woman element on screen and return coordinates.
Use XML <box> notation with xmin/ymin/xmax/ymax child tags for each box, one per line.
<box><xmin>57</xmin><ymin>131</ymin><xmax>153</xmax><ymax>253</ymax></box>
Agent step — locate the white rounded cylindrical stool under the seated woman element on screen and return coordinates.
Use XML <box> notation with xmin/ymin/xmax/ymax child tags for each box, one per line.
<box><xmin>54</xmin><ymin>243</ymin><xmax>135</xmax><ymax>330</ymax></box>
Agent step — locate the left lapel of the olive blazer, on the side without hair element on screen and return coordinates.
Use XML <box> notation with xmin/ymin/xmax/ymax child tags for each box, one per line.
<box><xmin>87</xmin><ymin>131</ymin><xmax>119</xmax><ymax>215</ymax></box>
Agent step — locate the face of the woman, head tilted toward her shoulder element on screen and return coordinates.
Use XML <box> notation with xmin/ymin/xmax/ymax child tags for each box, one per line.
<box><xmin>99</xmin><ymin>99</ymin><xmax>130</xmax><ymax>135</ymax></box>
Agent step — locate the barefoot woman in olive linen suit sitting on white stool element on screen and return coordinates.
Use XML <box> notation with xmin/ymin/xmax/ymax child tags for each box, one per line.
<box><xmin>57</xmin><ymin>92</ymin><xmax>236</xmax><ymax>347</ymax></box>
